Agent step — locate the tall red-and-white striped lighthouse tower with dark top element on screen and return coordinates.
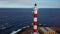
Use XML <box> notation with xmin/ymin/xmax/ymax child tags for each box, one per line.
<box><xmin>33</xmin><ymin>3</ymin><xmax>38</xmax><ymax>34</ymax></box>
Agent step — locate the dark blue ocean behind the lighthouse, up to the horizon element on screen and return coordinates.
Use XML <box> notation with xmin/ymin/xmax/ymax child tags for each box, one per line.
<box><xmin>0</xmin><ymin>8</ymin><xmax>60</xmax><ymax>34</ymax></box>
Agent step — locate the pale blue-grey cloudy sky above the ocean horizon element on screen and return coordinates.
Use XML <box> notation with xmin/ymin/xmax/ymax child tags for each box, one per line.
<box><xmin>0</xmin><ymin>0</ymin><xmax>60</xmax><ymax>8</ymax></box>
